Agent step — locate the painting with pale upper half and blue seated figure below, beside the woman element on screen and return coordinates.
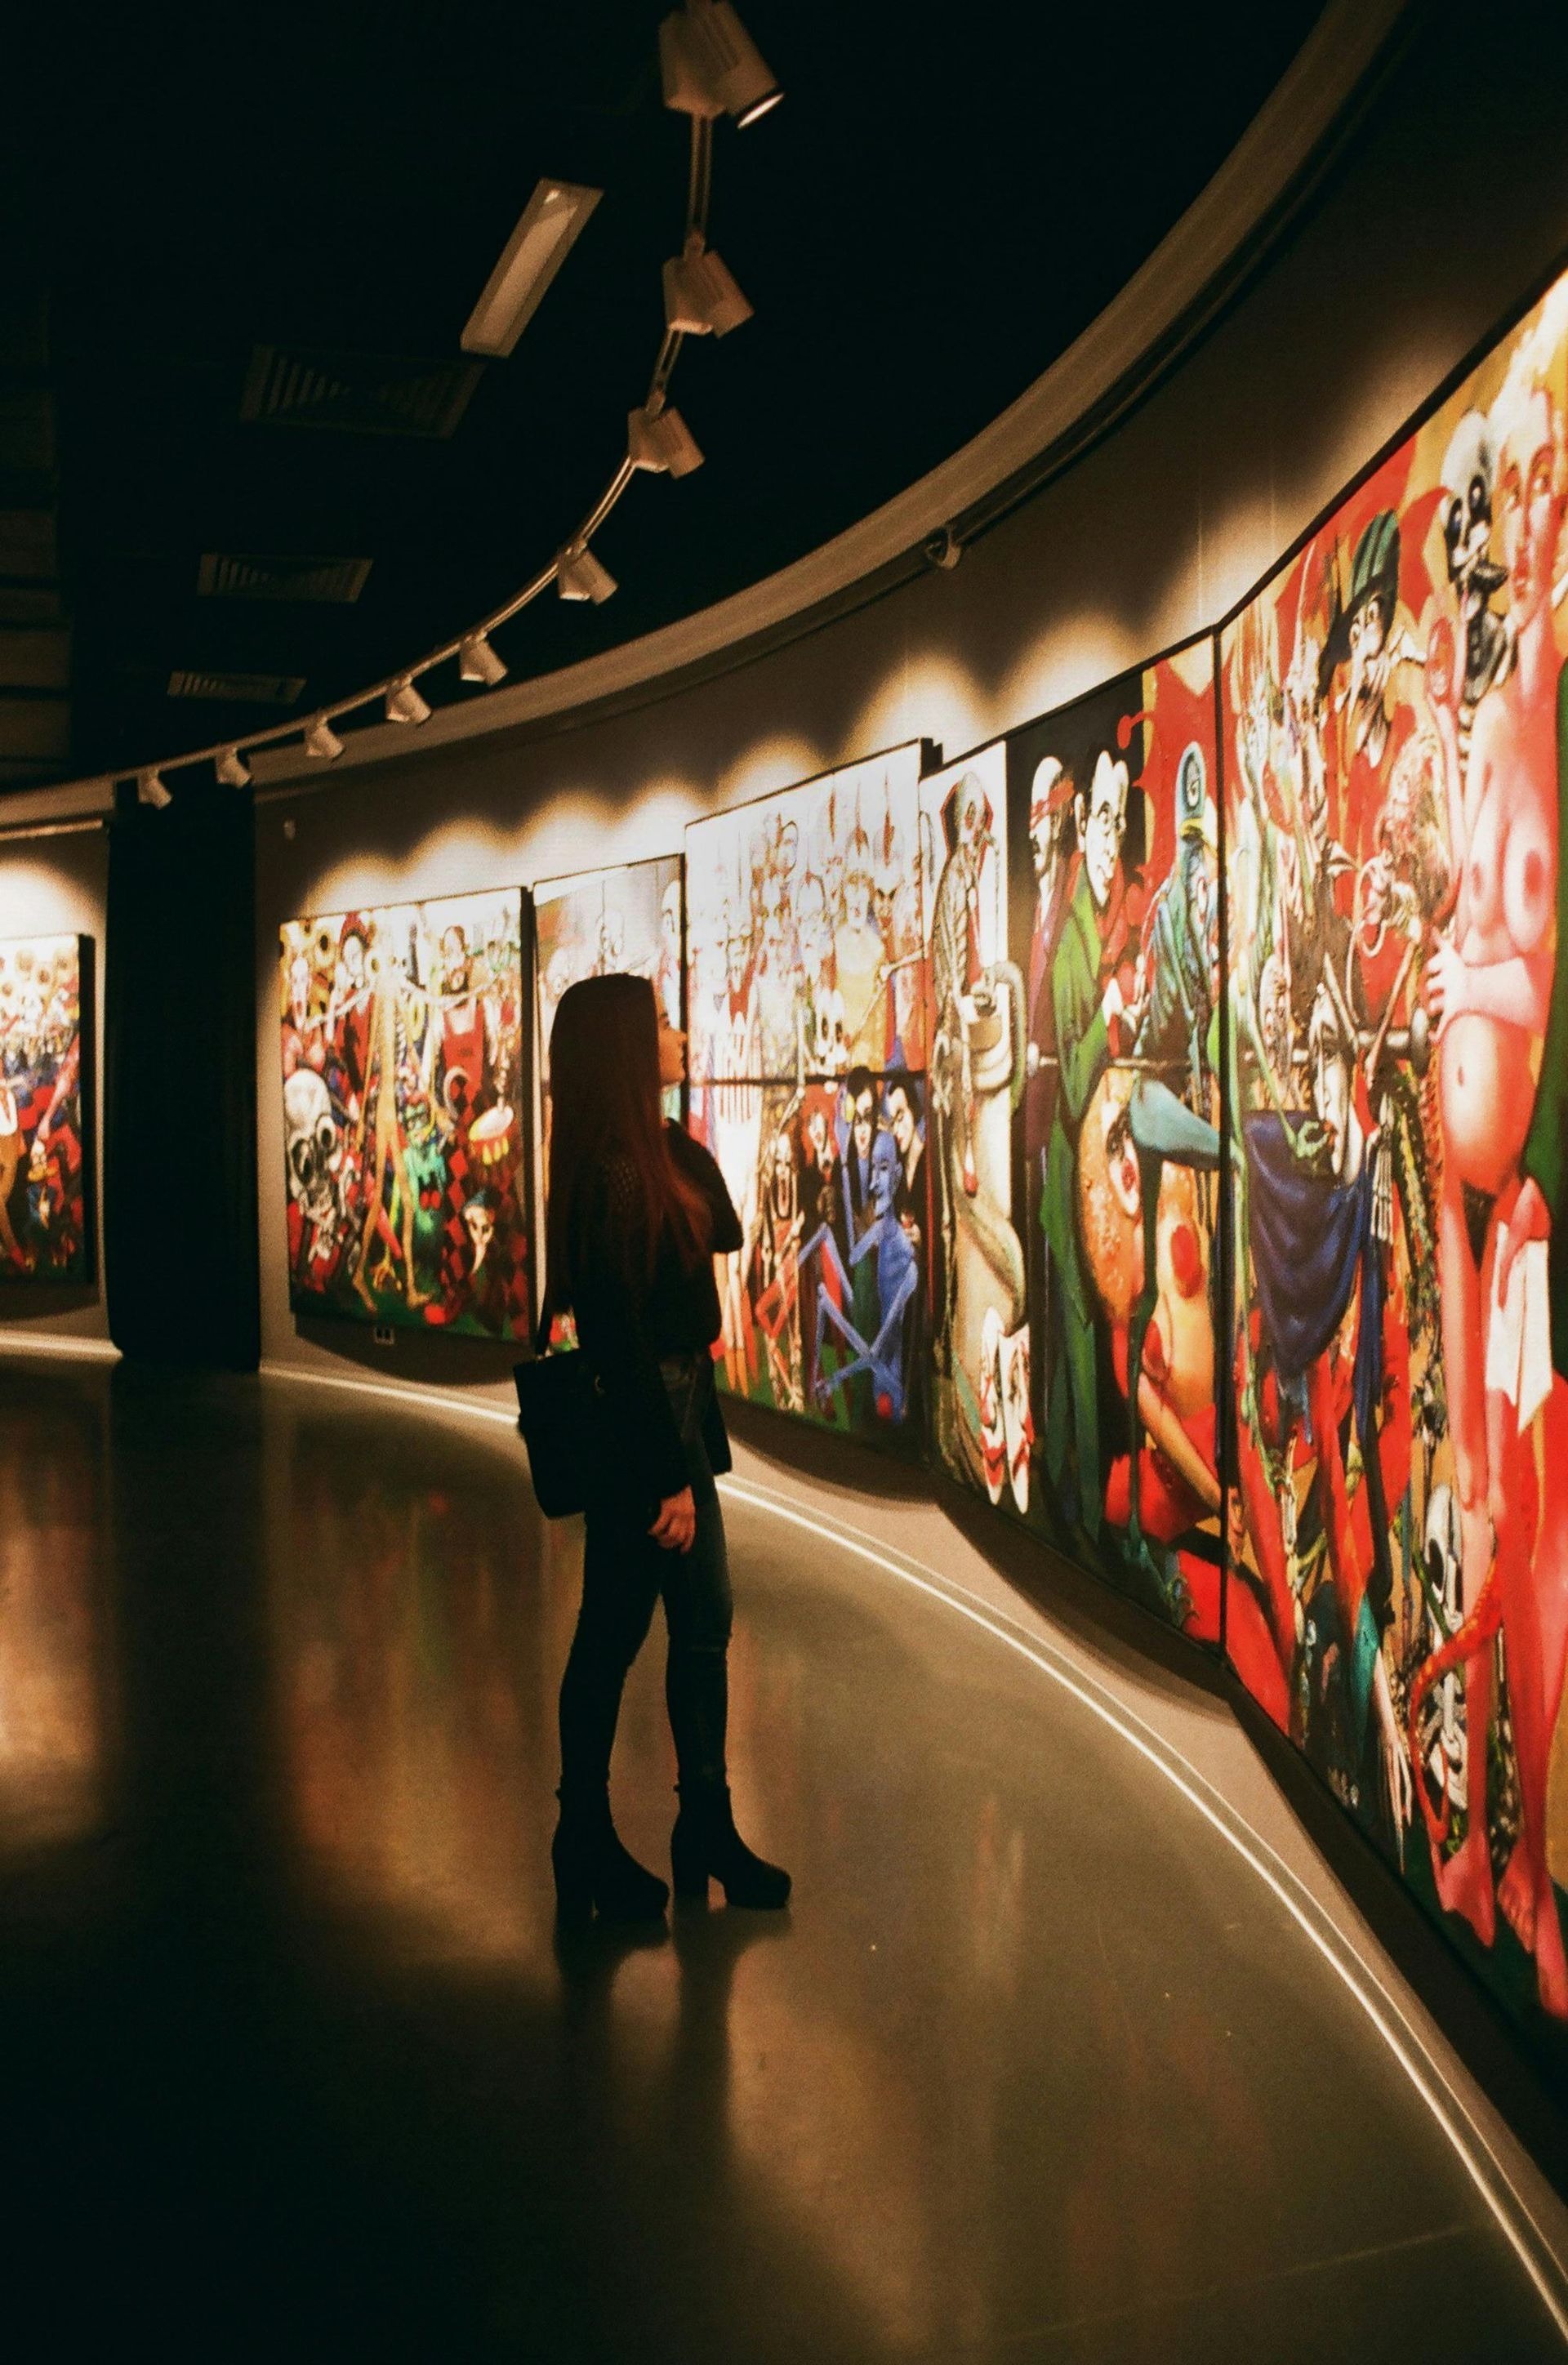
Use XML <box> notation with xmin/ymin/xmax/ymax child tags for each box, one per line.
<box><xmin>686</xmin><ymin>745</ymin><xmax>929</xmax><ymax>1452</ymax></box>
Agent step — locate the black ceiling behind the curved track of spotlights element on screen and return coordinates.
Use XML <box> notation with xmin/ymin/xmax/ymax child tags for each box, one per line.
<box><xmin>0</xmin><ymin>0</ymin><xmax>1317</xmax><ymax>781</ymax></box>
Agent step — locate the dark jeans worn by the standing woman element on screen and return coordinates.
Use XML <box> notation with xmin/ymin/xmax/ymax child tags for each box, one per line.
<box><xmin>560</xmin><ymin>1357</ymin><xmax>731</xmax><ymax>1805</ymax></box>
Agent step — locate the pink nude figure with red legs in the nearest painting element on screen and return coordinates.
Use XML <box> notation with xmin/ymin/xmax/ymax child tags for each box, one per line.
<box><xmin>1412</xmin><ymin>373</ymin><xmax>1568</xmax><ymax>2017</ymax></box>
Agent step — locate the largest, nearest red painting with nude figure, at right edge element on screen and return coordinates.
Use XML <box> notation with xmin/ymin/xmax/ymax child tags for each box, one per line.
<box><xmin>1223</xmin><ymin>254</ymin><xmax>1568</xmax><ymax>2027</ymax></box>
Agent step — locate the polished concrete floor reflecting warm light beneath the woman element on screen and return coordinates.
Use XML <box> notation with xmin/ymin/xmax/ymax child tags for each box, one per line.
<box><xmin>0</xmin><ymin>1357</ymin><xmax>1561</xmax><ymax>2365</ymax></box>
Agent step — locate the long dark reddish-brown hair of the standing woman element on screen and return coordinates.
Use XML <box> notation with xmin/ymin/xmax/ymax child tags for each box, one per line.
<box><xmin>546</xmin><ymin>977</ymin><xmax>712</xmax><ymax>1310</ymax></box>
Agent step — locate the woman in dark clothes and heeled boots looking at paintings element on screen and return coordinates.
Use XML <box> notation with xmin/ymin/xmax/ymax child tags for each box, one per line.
<box><xmin>546</xmin><ymin>977</ymin><xmax>790</xmax><ymax>1921</ymax></box>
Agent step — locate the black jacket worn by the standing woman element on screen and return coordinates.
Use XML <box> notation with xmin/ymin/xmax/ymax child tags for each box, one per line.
<box><xmin>570</xmin><ymin>1124</ymin><xmax>740</xmax><ymax>1502</ymax></box>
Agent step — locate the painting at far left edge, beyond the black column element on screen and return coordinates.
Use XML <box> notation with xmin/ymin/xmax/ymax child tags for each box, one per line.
<box><xmin>0</xmin><ymin>937</ymin><xmax>92</xmax><ymax>1285</ymax></box>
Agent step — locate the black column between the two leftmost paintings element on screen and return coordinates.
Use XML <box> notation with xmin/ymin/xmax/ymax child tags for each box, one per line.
<box><xmin>102</xmin><ymin>787</ymin><xmax>261</xmax><ymax>1372</ymax></box>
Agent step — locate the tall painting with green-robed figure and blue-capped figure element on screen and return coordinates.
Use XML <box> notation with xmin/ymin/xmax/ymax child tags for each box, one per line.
<box><xmin>998</xmin><ymin>641</ymin><xmax>1220</xmax><ymax>1644</ymax></box>
